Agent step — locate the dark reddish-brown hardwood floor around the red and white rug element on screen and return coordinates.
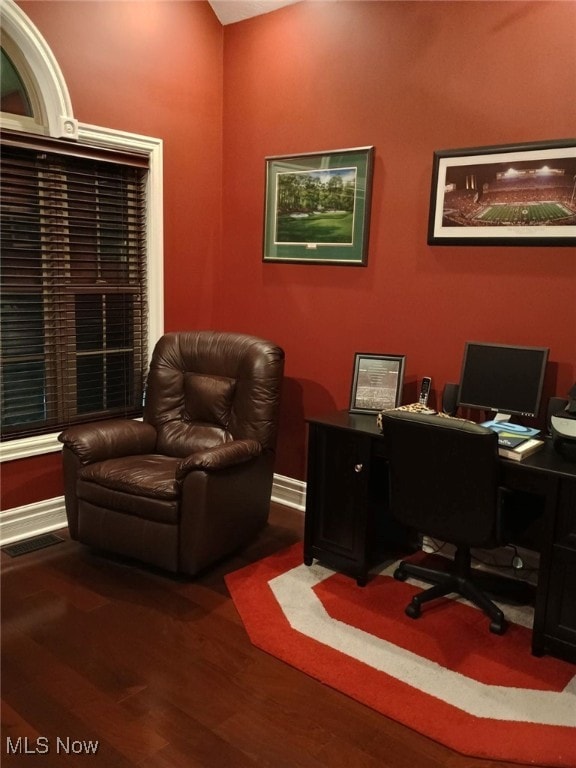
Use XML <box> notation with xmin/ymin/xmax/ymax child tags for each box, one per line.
<box><xmin>0</xmin><ymin>505</ymin><xmax>534</xmax><ymax>768</ymax></box>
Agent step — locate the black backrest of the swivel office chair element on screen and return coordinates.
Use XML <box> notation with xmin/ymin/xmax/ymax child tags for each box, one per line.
<box><xmin>382</xmin><ymin>411</ymin><xmax>500</xmax><ymax>547</ymax></box>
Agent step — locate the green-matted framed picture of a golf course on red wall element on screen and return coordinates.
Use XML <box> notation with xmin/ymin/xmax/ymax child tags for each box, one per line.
<box><xmin>263</xmin><ymin>147</ymin><xmax>374</xmax><ymax>267</ymax></box>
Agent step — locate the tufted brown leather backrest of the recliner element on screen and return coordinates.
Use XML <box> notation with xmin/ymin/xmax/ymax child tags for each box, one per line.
<box><xmin>144</xmin><ymin>331</ymin><xmax>284</xmax><ymax>457</ymax></box>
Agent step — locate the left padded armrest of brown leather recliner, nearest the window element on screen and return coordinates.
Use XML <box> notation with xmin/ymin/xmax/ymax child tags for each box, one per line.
<box><xmin>58</xmin><ymin>419</ymin><xmax>156</xmax><ymax>464</ymax></box>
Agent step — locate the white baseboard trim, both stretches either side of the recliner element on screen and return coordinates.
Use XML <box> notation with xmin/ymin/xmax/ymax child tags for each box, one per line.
<box><xmin>0</xmin><ymin>475</ymin><xmax>306</xmax><ymax>547</ymax></box>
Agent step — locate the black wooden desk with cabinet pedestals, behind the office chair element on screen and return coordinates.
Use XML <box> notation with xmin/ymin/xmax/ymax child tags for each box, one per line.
<box><xmin>304</xmin><ymin>411</ymin><xmax>576</xmax><ymax>663</ymax></box>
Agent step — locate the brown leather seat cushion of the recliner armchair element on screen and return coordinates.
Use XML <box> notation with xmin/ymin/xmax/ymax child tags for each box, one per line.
<box><xmin>77</xmin><ymin>454</ymin><xmax>180</xmax><ymax>523</ymax></box>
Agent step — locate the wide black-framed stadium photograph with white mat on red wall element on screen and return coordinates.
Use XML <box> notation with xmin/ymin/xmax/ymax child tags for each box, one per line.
<box><xmin>428</xmin><ymin>139</ymin><xmax>576</xmax><ymax>245</ymax></box>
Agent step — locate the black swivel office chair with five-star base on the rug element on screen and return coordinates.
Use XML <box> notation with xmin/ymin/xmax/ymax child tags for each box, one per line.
<box><xmin>382</xmin><ymin>411</ymin><xmax>533</xmax><ymax>635</ymax></box>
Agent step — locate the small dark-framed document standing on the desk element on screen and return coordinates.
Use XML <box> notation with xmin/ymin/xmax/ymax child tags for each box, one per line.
<box><xmin>349</xmin><ymin>352</ymin><xmax>406</xmax><ymax>413</ymax></box>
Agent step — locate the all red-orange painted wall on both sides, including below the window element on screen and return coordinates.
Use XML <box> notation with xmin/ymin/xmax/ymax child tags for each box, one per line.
<box><xmin>2</xmin><ymin>0</ymin><xmax>576</xmax><ymax>508</ymax></box>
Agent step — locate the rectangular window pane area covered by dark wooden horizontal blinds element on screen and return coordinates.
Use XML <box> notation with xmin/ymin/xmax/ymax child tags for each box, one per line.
<box><xmin>0</xmin><ymin>134</ymin><xmax>148</xmax><ymax>440</ymax></box>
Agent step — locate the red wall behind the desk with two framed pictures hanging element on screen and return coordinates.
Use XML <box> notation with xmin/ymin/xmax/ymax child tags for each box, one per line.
<box><xmin>215</xmin><ymin>1</ymin><xmax>576</xmax><ymax>478</ymax></box>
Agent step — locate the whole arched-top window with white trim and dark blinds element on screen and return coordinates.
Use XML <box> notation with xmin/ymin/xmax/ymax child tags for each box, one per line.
<box><xmin>0</xmin><ymin>0</ymin><xmax>163</xmax><ymax>461</ymax></box>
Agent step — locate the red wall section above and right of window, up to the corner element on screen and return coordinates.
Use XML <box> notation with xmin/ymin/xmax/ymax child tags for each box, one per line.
<box><xmin>18</xmin><ymin>0</ymin><xmax>223</xmax><ymax>330</ymax></box>
